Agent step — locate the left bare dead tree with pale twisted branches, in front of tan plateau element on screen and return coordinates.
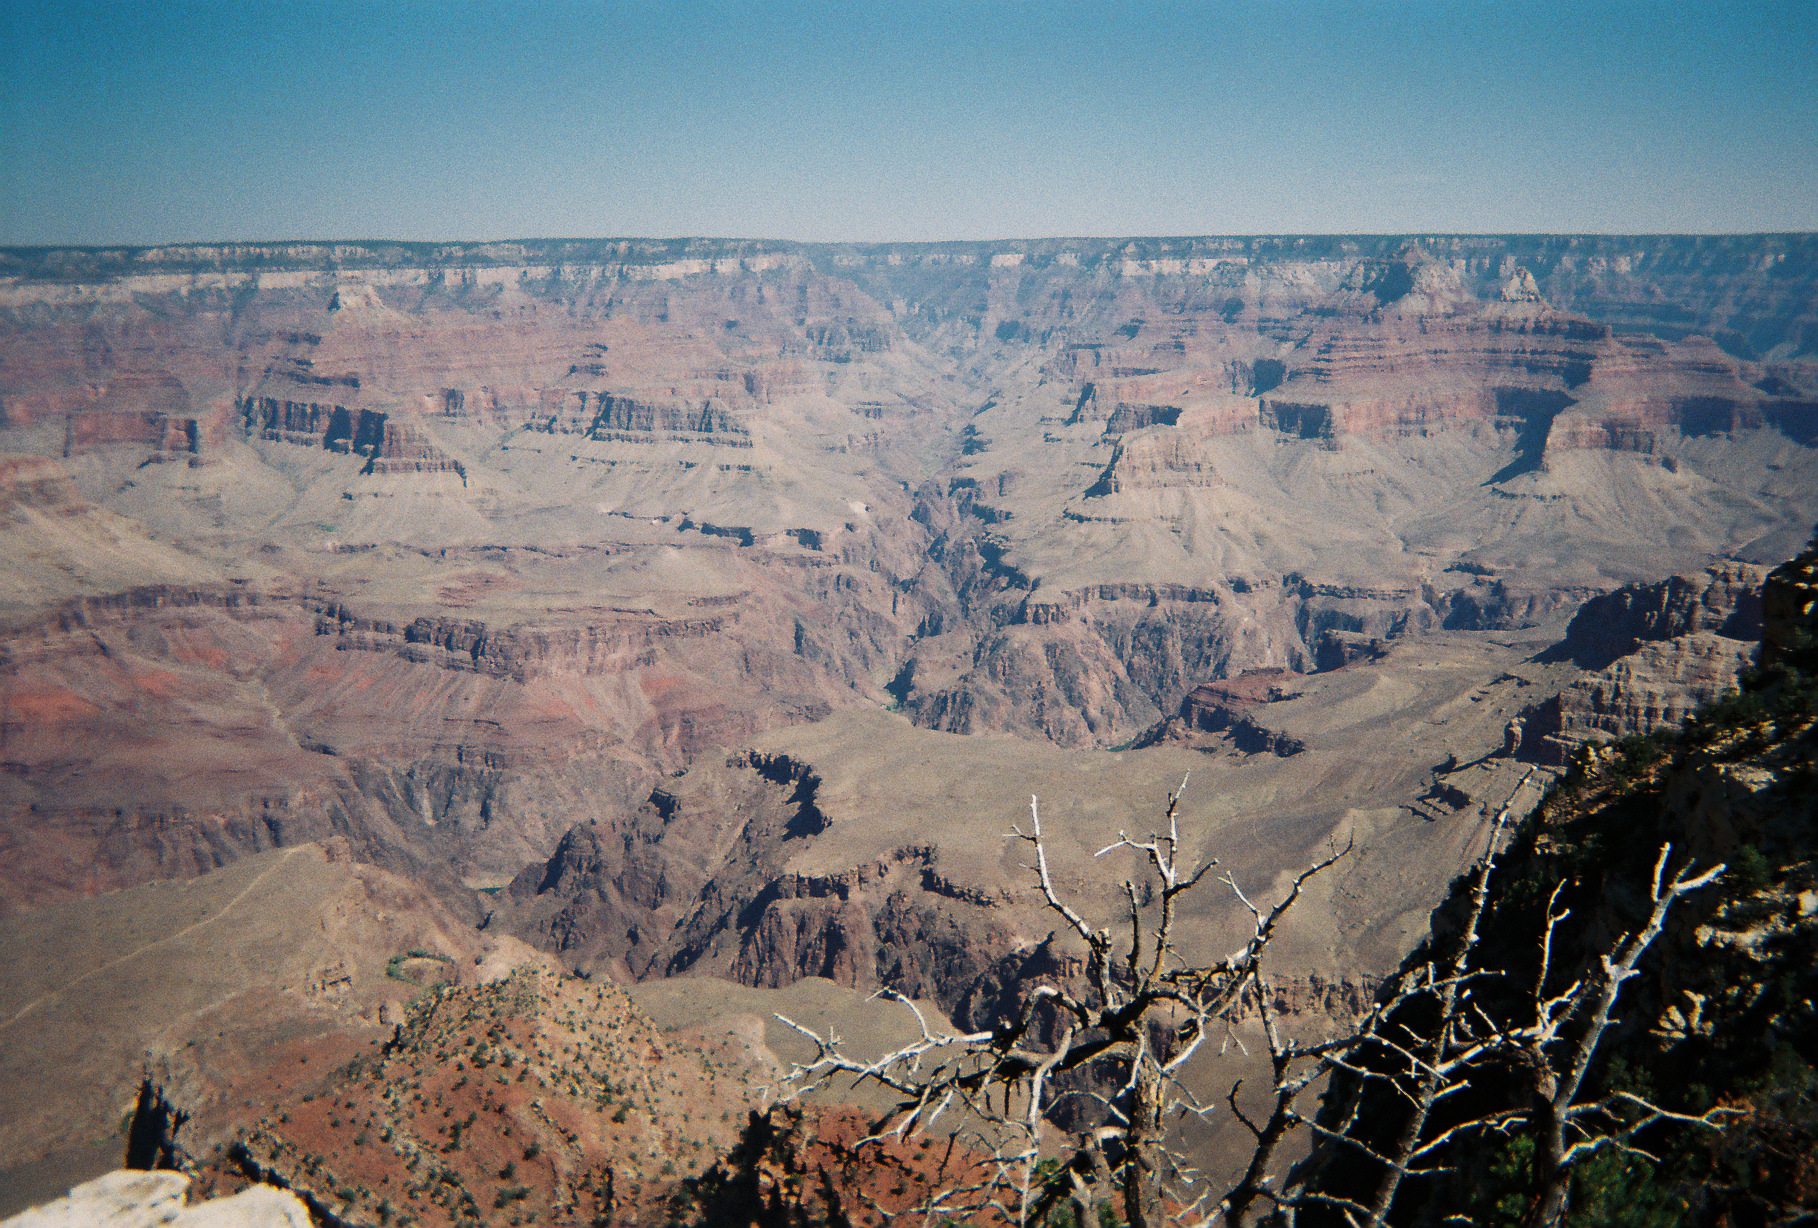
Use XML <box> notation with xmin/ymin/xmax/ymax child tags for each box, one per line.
<box><xmin>780</xmin><ymin>780</ymin><xmax>1349</xmax><ymax>1228</ymax></box>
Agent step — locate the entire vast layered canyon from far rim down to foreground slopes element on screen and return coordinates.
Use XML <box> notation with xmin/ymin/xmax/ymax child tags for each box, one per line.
<box><xmin>0</xmin><ymin>235</ymin><xmax>1818</xmax><ymax>1197</ymax></box>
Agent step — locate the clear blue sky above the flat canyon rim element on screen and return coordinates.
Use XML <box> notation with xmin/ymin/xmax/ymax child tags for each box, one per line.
<box><xmin>0</xmin><ymin>0</ymin><xmax>1818</xmax><ymax>244</ymax></box>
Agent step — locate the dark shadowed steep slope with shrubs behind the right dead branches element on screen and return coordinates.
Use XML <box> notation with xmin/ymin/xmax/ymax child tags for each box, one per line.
<box><xmin>1307</xmin><ymin>540</ymin><xmax>1818</xmax><ymax>1224</ymax></box>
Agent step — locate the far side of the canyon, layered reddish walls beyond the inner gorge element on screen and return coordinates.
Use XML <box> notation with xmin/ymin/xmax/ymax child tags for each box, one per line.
<box><xmin>0</xmin><ymin>237</ymin><xmax>1818</xmax><ymax>924</ymax></box>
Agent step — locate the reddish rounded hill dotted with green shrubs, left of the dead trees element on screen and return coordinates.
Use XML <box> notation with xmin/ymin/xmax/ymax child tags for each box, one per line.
<box><xmin>197</xmin><ymin>970</ymin><xmax>754</xmax><ymax>1228</ymax></box>
